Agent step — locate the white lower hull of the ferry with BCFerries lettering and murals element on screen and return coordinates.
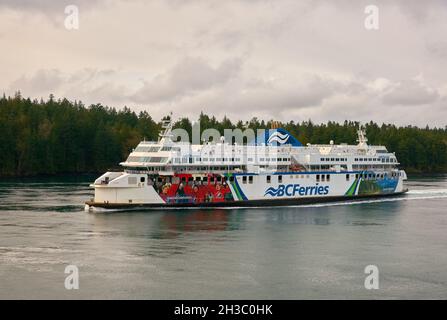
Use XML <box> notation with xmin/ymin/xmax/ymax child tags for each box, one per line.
<box><xmin>86</xmin><ymin>170</ymin><xmax>406</xmax><ymax>209</ymax></box>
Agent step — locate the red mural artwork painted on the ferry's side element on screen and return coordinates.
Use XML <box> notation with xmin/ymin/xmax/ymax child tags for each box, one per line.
<box><xmin>155</xmin><ymin>174</ymin><xmax>233</xmax><ymax>203</ymax></box>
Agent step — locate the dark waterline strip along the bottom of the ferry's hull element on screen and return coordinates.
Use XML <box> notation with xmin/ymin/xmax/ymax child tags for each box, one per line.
<box><xmin>85</xmin><ymin>189</ymin><xmax>408</xmax><ymax>211</ymax></box>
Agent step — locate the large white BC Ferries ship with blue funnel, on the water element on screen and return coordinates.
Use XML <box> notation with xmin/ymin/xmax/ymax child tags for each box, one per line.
<box><xmin>85</xmin><ymin>116</ymin><xmax>407</xmax><ymax>210</ymax></box>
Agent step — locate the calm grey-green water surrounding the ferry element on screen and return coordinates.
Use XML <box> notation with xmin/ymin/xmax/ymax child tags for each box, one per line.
<box><xmin>0</xmin><ymin>176</ymin><xmax>447</xmax><ymax>299</ymax></box>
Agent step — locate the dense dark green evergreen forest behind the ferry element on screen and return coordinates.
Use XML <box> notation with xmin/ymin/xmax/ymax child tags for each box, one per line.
<box><xmin>0</xmin><ymin>93</ymin><xmax>447</xmax><ymax>177</ymax></box>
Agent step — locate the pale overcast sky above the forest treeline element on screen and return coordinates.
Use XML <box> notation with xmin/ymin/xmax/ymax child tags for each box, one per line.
<box><xmin>0</xmin><ymin>0</ymin><xmax>447</xmax><ymax>127</ymax></box>
